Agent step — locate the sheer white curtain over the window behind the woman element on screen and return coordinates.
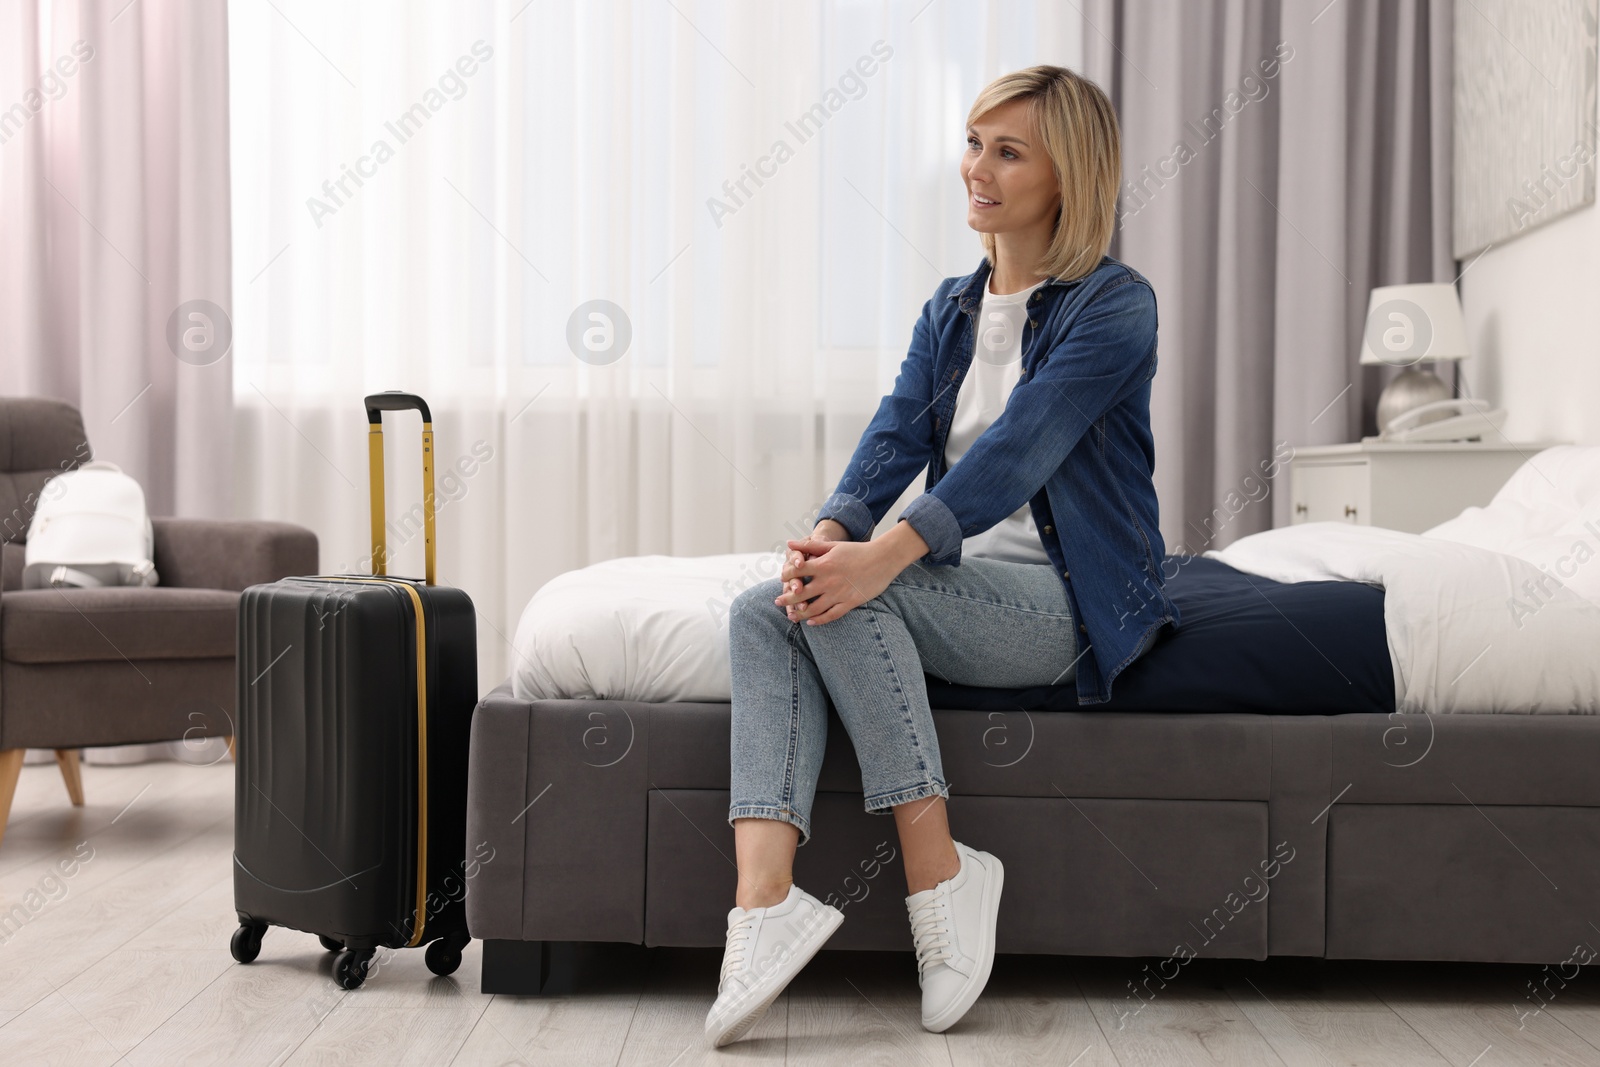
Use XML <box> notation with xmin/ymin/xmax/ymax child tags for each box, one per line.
<box><xmin>230</xmin><ymin>0</ymin><xmax>1082</xmax><ymax>688</ymax></box>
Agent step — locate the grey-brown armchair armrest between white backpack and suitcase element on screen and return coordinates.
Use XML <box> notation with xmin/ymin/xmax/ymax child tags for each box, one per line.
<box><xmin>150</xmin><ymin>518</ymin><xmax>317</xmax><ymax>591</ymax></box>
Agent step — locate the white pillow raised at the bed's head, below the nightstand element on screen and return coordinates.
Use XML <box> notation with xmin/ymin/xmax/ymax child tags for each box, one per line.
<box><xmin>1422</xmin><ymin>445</ymin><xmax>1600</xmax><ymax>601</ymax></box>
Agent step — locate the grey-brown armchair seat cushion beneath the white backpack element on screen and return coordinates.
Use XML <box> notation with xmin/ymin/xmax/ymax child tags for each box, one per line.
<box><xmin>0</xmin><ymin>585</ymin><xmax>238</xmax><ymax>664</ymax></box>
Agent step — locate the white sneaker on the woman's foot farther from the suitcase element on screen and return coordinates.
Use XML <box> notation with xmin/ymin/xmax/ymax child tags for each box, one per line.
<box><xmin>906</xmin><ymin>841</ymin><xmax>1005</xmax><ymax>1033</ymax></box>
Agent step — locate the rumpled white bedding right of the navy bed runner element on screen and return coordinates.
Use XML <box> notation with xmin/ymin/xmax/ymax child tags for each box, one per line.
<box><xmin>1205</xmin><ymin>445</ymin><xmax>1600</xmax><ymax>713</ymax></box>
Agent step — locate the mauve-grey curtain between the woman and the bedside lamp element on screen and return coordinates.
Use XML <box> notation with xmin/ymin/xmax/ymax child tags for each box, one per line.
<box><xmin>1083</xmin><ymin>0</ymin><xmax>1456</xmax><ymax>552</ymax></box>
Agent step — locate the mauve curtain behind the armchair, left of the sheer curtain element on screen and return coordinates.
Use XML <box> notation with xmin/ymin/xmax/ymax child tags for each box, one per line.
<box><xmin>0</xmin><ymin>0</ymin><xmax>234</xmax><ymax>518</ymax></box>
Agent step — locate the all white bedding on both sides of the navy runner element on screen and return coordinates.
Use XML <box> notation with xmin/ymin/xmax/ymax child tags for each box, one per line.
<box><xmin>512</xmin><ymin>445</ymin><xmax>1600</xmax><ymax>713</ymax></box>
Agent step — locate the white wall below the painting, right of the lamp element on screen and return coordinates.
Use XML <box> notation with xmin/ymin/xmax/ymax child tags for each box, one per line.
<box><xmin>1461</xmin><ymin>89</ymin><xmax>1600</xmax><ymax>445</ymax></box>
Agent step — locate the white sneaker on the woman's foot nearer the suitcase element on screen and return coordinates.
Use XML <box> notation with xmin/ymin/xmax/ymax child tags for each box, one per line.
<box><xmin>706</xmin><ymin>885</ymin><xmax>845</xmax><ymax>1048</ymax></box>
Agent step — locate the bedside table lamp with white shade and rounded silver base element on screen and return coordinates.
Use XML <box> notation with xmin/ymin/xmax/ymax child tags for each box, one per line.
<box><xmin>1362</xmin><ymin>282</ymin><xmax>1470</xmax><ymax>434</ymax></box>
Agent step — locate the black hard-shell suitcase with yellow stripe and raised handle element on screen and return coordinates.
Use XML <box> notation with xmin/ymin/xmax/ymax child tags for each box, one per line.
<box><xmin>232</xmin><ymin>392</ymin><xmax>478</xmax><ymax>989</ymax></box>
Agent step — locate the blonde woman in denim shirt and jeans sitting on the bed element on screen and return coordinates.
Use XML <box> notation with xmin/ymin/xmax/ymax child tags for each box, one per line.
<box><xmin>706</xmin><ymin>66</ymin><xmax>1178</xmax><ymax>1045</ymax></box>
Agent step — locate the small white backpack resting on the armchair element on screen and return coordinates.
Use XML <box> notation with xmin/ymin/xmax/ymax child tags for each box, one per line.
<box><xmin>22</xmin><ymin>461</ymin><xmax>157</xmax><ymax>589</ymax></box>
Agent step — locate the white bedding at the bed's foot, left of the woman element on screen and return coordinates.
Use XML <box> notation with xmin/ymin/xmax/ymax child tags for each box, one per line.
<box><xmin>512</xmin><ymin>550</ymin><xmax>784</xmax><ymax>704</ymax></box>
